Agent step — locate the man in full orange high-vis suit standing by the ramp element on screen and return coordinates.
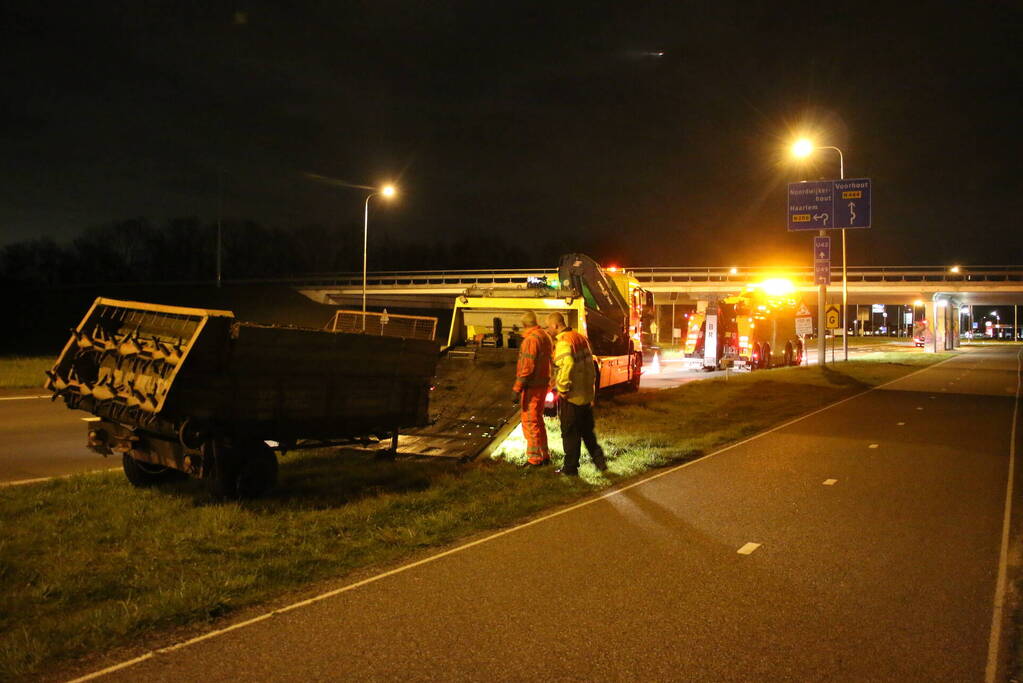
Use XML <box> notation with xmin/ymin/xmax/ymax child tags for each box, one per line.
<box><xmin>513</xmin><ymin>311</ymin><xmax>553</xmax><ymax>466</ymax></box>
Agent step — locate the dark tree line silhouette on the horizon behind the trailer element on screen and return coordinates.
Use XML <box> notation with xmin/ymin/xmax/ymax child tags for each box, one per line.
<box><xmin>0</xmin><ymin>218</ymin><xmax>578</xmax><ymax>287</ymax></box>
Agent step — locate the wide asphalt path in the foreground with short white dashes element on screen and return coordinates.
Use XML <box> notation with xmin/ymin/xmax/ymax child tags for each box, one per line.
<box><xmin>81</xmin><ymin>347</ymin><xmax>1020</xmax><ymax>681</ymax></box>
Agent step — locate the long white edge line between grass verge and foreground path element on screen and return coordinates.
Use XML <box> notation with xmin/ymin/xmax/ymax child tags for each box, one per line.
<box><xmin>68</xmin><ymin>356</ymin><xmax>962</xmax><ymax>683</ymax></box>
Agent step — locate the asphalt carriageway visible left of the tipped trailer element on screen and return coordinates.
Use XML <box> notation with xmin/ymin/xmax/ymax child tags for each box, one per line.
<box><xmin>0</xmin><ymin>390</ymin><xmax>112</xmax><ymax>486</ymax></box>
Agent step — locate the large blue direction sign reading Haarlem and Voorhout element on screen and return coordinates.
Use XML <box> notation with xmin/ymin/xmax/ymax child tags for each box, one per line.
<box><xmin>789</xmin><ymin>178</ymin><xmax>871</xmax><ymax>230</ymax></box>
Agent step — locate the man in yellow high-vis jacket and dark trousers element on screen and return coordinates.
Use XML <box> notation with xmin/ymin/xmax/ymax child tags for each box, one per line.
<box><xmin>547</xmin><ymin>311</ymin><xmax>608</xmax><ymax>476</ymax></box>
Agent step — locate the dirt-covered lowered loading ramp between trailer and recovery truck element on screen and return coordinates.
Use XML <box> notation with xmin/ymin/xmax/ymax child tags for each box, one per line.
<box><xmin>374</xmin><ymin>347</ymin><xmax>519</xmax><ymax>462</ymax></box>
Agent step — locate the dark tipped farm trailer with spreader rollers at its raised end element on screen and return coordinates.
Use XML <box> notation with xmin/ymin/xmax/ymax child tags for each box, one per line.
<box><xmin>45</xmin><ymin>299</ymin><xmax>438</xmax><ymax>498</ymax></box>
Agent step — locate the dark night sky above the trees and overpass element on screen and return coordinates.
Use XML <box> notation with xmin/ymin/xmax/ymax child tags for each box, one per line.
<box><xmin>0</xmin><ymin>0</ymin><xmax>1023</xmax><ymax>268</ymax></box>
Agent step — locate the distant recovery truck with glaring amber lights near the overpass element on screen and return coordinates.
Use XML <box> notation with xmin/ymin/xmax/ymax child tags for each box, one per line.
<box><xmin>684</xmin><ymin>279</ymin><xmax>804</xmax><ymax>371</ymax></box>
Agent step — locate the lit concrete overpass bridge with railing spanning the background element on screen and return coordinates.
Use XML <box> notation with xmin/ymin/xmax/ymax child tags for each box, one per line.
<box><xmin>257</xmin><ymin>266</ymin><xmax>1023</xmax><ymax>348</ymax></box>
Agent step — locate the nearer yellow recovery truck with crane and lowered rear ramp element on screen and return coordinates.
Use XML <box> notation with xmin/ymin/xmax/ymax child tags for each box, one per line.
<box><xmin>390</xmin><ymin>254</ymin><xmax>654</xmax><ymax>461</ymax></box>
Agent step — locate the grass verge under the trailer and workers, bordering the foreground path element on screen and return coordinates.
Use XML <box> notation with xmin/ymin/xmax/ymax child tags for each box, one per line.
<box><xmin>0</xmin><ymin>353</ymin><xmax>942</xmax><ymax>679</ymax></box>
